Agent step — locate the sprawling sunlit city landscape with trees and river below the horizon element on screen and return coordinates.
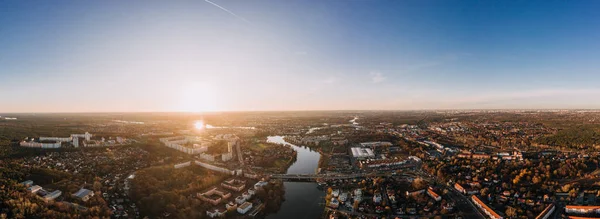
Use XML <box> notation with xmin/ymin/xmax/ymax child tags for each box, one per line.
<box><xmin>0</xmin><ymin>110</ymin><xmax>600</xmax><ymax>219</ymax></box>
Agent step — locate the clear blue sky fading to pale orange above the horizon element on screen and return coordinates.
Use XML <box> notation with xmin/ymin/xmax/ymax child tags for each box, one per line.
<box><xmin>0</xmin><ymin>0</ymin><xmax>600</xmax><ymax>112</ymax></box>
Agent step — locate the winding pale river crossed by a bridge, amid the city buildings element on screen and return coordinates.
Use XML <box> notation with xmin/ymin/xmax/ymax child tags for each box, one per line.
<box><xmin>266</xmin><ymin>136</ymin><xmax>325</xmax><ymax>219</ymax></box>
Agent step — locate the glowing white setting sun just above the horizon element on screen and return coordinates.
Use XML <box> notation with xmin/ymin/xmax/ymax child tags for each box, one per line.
<box><xmin>179</xmin><ymin>83</ymin><xmax>219</xmax><ymax>112</ymax></box>
